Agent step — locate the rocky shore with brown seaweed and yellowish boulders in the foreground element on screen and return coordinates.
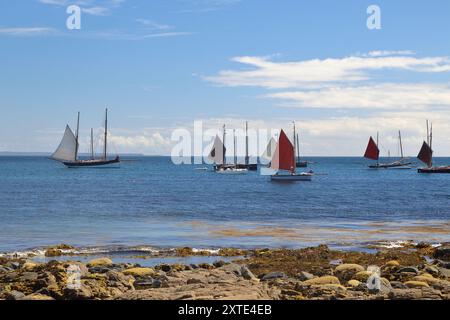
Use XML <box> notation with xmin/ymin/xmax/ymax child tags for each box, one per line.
<box><xmin>0</xmin><ymin>243</ymin><xmax>450</xmax><ymax>300</ymax></box>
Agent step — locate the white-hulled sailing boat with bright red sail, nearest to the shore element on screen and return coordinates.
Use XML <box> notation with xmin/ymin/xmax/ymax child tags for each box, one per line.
<box><xmin>270</xmin><ymin>125</ymin><xmax>313</xmax><ymax>182</ymax></box>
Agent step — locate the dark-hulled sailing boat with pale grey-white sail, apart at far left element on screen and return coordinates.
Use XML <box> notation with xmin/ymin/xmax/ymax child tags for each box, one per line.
<box><xmin>52</xmin><ymin>109</ymin><xmax>120</xmax><ymax>168</ymax></box>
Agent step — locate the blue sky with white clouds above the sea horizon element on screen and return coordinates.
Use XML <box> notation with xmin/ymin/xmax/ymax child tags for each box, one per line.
<box><xmin>0</xmin><ymin>0</ymin><xmax>450</xmax><ymax>155</ymax></box>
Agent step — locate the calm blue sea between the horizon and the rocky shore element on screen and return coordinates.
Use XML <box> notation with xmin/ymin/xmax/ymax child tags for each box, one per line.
<box><xmin>0</xmin><ymin>156</ymin><xmax>450</xmax><ymax>252</ymax></box>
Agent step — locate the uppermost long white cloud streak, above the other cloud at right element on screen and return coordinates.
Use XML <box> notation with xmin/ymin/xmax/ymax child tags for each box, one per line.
<box><xmin>205</xmin><ymin>55</ymin><xmax>450</xmax><ymax>89</ymax></box>
